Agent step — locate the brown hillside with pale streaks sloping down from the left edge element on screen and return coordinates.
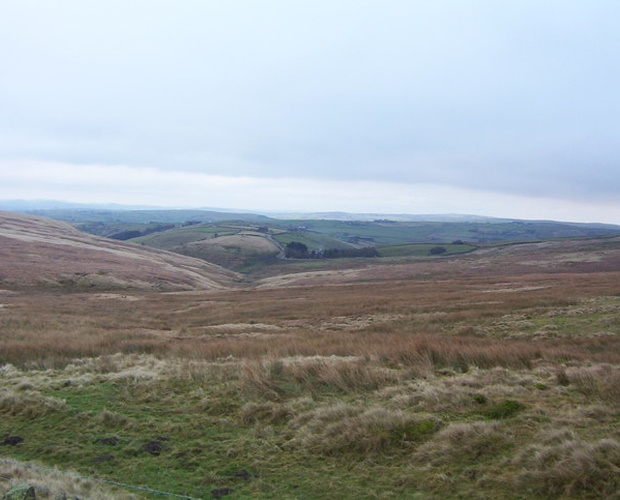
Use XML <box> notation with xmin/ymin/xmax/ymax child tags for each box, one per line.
<box><xmin>0</xmin><ymin>211</ymin><xmax>238</xmax><ymax>290</ymax></box>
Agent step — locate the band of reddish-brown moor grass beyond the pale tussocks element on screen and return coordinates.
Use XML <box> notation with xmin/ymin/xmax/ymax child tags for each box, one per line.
<box><xmin>0</xmin><ymin>273</ymin><xmax>620</xmax><ymax>370</ymax></box>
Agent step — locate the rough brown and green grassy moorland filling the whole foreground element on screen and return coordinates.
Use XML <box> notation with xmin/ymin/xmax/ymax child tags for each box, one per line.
<box><xmin>0</xmin><ymin>240</ymin><xmax>620</xmax><ymax>498</ymax></box>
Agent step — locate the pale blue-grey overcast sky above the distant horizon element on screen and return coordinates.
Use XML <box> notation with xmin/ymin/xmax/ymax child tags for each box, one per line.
<box><xmin>0</xmin><ymin>0</ymin><xmax>620</xmax><ymax>224</ymax></box>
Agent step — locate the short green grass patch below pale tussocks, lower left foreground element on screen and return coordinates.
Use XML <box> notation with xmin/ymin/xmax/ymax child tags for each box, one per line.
<box><xmin>0</xmin><ymin>372</ymin><xmax>444</xmax><ymax>498</ymax></box>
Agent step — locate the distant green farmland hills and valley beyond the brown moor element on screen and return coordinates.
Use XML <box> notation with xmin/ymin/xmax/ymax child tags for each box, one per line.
<box><xmin>1</xmin><ymin>203</ymin><xmax>620</xmax><ymax>273</ymax></box>
